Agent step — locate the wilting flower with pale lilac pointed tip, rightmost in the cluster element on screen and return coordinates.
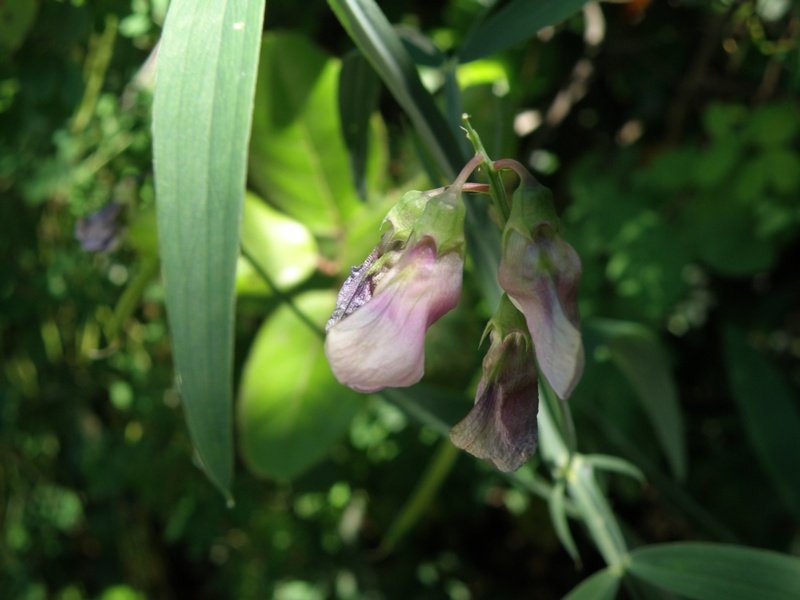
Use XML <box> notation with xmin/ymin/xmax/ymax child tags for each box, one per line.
<box><xmin>498</xmin><ymin>179</ymin><xmax>584</xmax><ymax>399</ymax></box>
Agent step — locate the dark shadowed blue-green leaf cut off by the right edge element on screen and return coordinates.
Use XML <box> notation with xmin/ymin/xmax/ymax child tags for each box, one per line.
<box><xmin>723</xmin><ymin>326</ymin><xmax>800</xmax><ymax>516</ymax></box>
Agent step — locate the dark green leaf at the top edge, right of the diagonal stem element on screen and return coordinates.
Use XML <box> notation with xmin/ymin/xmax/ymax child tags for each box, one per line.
<box><xmin>458</xmin><ymin>0</ymin><xmax>587</xmax><ymax>63</ymax></box>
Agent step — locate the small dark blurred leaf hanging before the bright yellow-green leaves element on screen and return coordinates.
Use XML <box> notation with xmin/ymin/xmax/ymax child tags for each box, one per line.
<box><xmin>339</xmin><ymin>51</ymin><xmax>381</xmax><ymax>199</ymax></box>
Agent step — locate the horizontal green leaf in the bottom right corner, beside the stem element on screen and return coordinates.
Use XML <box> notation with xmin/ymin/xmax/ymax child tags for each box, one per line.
<box><xmin>628</xmin><ymin>543</ymin><xmax>800</xmax><ymax>600</ymax></box>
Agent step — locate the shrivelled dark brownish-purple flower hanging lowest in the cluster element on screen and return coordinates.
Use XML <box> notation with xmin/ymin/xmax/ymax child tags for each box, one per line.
<box><xmin>450</xmin><ymin>295</ymin><xmax>539</xmax><ymax>472</ymax></box>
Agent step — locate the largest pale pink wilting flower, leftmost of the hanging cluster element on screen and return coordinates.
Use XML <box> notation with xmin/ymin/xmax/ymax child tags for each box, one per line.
<box><xmin>325</xmin><ymin>188</ymin><xmax>464</xmax><ymax>392</ymax></box>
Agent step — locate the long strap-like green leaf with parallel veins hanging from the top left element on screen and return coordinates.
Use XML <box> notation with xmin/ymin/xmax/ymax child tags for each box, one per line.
<box><xmin>153</xmin><ymin>0</ymin><xmax>264</xmax><ymax>500</ymax></box>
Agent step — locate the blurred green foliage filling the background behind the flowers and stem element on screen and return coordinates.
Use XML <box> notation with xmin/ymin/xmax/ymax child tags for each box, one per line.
<box><xmin>0</xmin><ymin>0</ymin><xmax>800</xmax><ymax>600</ymax></box>
